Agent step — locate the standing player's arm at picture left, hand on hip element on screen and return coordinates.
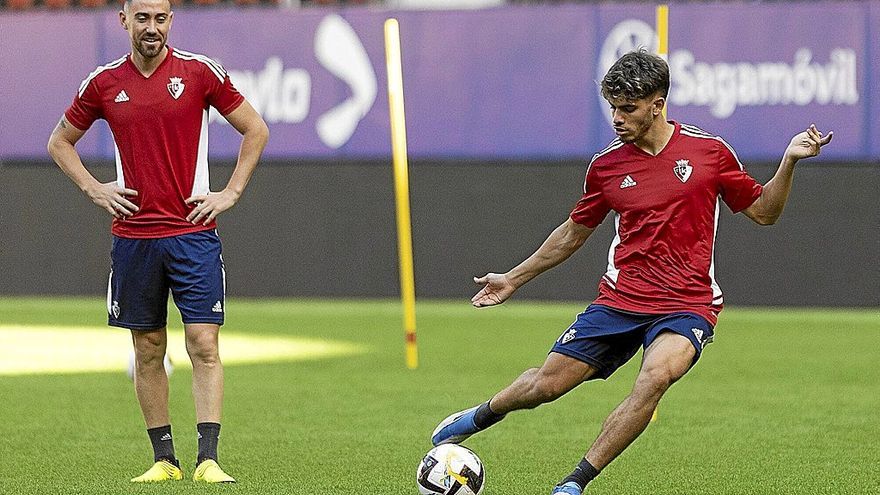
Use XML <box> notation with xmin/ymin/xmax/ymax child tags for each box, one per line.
<box><xmin>48</xmin><ymin>116</ymin><xmax>138</xmax><ymax>218</ymax></box>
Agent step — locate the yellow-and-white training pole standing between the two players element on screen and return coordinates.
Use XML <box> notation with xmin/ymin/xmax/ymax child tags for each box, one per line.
<box><xmin>385</xmin><ymin>19</ymin><xmax>419</xmax><ymax>369</ymax></box>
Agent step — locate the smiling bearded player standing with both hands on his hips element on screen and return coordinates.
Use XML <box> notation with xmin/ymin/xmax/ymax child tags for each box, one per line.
<box><xmin>48</xmin><ymin>0</ymin><xmax>269</xmax><ymax>482</ymax></box>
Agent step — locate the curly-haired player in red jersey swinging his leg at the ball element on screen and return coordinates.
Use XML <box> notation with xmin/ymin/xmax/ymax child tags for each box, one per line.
<box><xmin>431</xmin><ymin>50</ymin><xmax>832</xmax><ymax>495</ymax></box>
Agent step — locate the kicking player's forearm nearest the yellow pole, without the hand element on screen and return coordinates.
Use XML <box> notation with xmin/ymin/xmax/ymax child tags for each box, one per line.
<box><xmin>506</xmin><ymin>219</ymin><xmax>592</xmax><ymax>287</ymax></box>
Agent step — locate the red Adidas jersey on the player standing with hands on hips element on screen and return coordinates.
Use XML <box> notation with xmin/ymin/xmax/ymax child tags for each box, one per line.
<box><xmin>64</xmin><ymin>47</ymin><xmax>244</xmax><ymax>238</ymax></box>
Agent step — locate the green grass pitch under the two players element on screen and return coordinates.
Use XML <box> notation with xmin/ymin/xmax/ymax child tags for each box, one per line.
<box><xmin>0</xmin><ymin>298</ymin><xmax>880</xmax><ymax>495</ymax></box>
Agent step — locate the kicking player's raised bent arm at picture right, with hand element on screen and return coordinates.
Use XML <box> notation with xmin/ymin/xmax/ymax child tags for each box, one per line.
<box><xmin>743</xmin><ymin>124</ymin><xmax>834</xmax><ymax>225</ymax></box>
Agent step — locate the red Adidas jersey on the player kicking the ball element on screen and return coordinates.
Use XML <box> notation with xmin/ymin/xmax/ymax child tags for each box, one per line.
<box><xmin>571</xmin><ymin>122</ymin><xmax>763</xmax><ymax>325</ymax></box>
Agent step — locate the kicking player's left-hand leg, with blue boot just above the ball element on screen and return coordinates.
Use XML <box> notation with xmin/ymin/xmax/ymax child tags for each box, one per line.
<box><xmin>431</xmin><ymin>352</ymin><xmax>596</xmax><ymax>445</ymax></box>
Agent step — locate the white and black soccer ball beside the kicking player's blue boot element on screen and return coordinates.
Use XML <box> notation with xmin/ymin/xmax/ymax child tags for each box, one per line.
<box><xmin>416</xmin><ymin>444</ymin><xmax>486</xmax><ymax>495</ymax></box>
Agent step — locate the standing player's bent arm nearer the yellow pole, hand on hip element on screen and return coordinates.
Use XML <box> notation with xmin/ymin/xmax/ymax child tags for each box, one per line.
<box><xmin>186</xmin><ymin>101</ymin><xmax>269</xmax><ymax>225</ymax></box>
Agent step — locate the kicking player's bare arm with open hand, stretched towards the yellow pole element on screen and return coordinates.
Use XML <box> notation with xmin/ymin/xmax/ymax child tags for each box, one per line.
<box><xmin>471</xmin><ymin>218</ymin><xmax>594</xmax><ymax>308</ymax></box>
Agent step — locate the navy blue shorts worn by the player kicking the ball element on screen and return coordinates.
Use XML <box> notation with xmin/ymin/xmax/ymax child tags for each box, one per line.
<box><xmin>551</xmin><ymin>304</ymin><xmax>714</xmax><ymax>380</ymax></box>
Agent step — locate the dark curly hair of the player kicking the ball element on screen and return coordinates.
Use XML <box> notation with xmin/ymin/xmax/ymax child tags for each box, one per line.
<box><xmin>602</xmin><ymin>48</ymin><xmax>669</xmax><ymax>100</ymax></box>
